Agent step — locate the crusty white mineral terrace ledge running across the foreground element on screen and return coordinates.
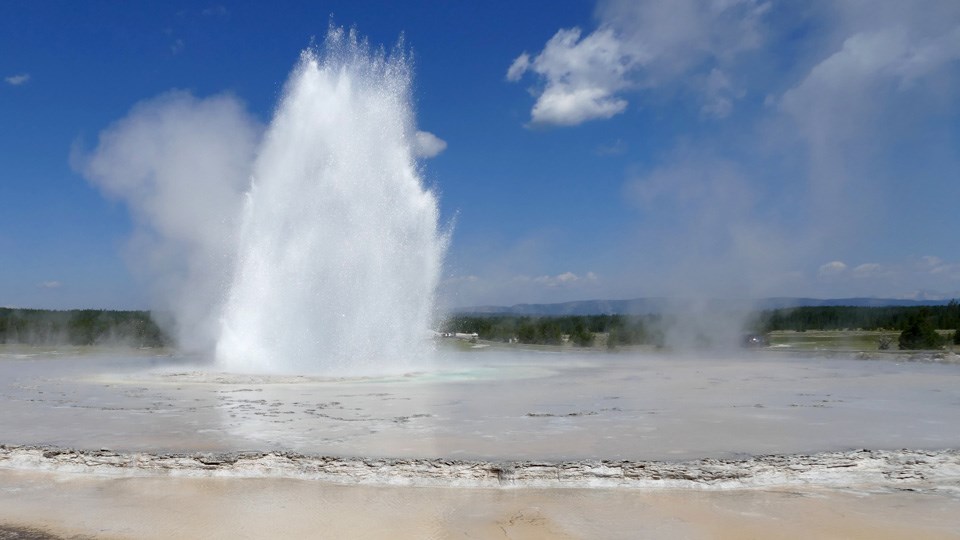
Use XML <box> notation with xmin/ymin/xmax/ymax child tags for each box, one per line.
<box><xmin>0</xmin><ymin>446</ymin><xmax>960</xmax><ymax>496</ymax></box>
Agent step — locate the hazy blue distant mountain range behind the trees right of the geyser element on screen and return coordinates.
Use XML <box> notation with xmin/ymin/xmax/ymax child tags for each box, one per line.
<box><xmin>453</xmin><ymin>297</ymin><xmax>949</xmax><ymax>316</ymax></box>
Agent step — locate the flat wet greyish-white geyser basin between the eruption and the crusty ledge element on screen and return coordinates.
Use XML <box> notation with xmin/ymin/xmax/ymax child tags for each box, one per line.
<box><xmin>0</xmin><ymin>350</ymin><xmax>960</xmax><ymax>460</ymax></box>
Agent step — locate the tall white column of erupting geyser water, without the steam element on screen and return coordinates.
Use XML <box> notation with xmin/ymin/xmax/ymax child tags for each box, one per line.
<box><xmin>216</xmin><ymin>29</ymin><xmax>445</xmax><ymax>375</ymax></box>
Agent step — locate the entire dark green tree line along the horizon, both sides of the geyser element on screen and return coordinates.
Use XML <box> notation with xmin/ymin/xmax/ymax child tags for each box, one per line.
<box><xmin>7</xmin><ymin>300</ymin><xmax>960</xmax><ymax>349</ymax></box>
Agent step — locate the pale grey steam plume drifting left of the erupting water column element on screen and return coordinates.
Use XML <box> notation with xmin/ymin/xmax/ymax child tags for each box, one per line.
<box><xmin>72</xmin><ymin>91</ymin><xmax>261</xmax><ymax>348</ymax></box>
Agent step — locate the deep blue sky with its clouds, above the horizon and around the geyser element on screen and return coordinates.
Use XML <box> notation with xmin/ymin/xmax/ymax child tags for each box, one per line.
<box><xmin>0</xmin><ymin>0</ymin><xmax>960</xmax><ymax>308</ymax></box>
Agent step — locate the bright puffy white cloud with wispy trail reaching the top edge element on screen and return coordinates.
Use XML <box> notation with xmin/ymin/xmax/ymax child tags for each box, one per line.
<box><xmin>507</xmin><ymin>0</ymin><xmax>769</xmax><ymax>126</ymax></box>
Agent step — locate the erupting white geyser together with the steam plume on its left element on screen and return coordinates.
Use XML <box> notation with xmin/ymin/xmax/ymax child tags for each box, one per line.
<box><xmin>74</xmin><ymin>26</ymin><xmax>446</xmax><ymax>376</ymax></box>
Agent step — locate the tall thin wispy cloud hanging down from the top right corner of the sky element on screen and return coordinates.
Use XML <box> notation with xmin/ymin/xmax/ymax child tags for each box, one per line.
<box><xmin>769</xmin><ymin>0</ymin><xmax>960</xmax><ymax>255</ymax></box>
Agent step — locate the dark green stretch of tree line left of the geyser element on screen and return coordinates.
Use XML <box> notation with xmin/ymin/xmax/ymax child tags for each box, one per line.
<box><xmin>0</xmin><ymin>308</ymin><xmax>171</xmax><ymax>347</ymax></box>
